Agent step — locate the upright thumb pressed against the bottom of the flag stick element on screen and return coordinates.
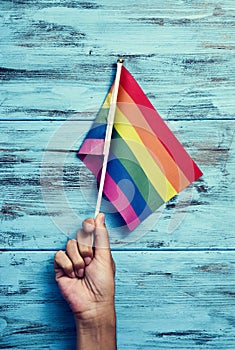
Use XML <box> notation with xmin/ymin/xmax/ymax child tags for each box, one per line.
<box><xmin>95</xmin><ymin>213</ymin><xmax>110</xmax><ymax>254</ymax></box>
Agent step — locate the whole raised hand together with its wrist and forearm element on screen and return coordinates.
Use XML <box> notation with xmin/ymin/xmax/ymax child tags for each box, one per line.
<box><xmin>54</xmin><ymin>214</ymin><xmax>116</xmax><ymax>350</ymax></box>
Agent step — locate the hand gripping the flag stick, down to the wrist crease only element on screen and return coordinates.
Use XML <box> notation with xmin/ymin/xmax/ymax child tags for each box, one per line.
<box><xmin>55</xmin><ymin>214</ymin><xmax>115</xmax><ymax>318</ymax></box>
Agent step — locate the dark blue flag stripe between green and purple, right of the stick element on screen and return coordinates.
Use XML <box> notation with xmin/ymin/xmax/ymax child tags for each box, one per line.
<box><xmin>107</xmin><ymin>155</ymin><xmax>152</xmax><ymax>220</ymax></box>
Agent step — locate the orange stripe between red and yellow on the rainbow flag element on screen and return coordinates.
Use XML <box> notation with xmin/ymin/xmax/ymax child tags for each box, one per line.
<box><xmin>115</xmin><ymin>86</ymin><xmax>190</xmax><ymax>192</ymax></box>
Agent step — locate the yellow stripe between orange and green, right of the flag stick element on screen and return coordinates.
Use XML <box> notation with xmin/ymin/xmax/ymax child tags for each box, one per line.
<box><xmin>114</xmin><ymin>108</ymin><xmax>177</xmax><ymax>202</ymax></box>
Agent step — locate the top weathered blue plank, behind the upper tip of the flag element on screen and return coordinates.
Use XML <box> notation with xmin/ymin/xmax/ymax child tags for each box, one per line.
<box><xmin>0</xmin><ymin>0</ymin><xmax>235</xmax><ymax>120</ymax></box>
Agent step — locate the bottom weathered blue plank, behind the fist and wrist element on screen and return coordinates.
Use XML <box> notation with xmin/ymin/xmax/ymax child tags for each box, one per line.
<box><xmin>0</xmin><ymin>252</ymin><xmax>235</xmax><ymax>350</ymax></box>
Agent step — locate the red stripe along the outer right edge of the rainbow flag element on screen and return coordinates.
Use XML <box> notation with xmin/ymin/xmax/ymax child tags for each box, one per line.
<box><xmin>120</xmin><ymin>67</ymin><xmax>202</xmax><ymax>182</ymax></box>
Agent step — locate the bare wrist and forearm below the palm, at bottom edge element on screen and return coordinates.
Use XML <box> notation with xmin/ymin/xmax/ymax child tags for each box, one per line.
<box><xmin>75</xmin><ymin>308</ymin><xmax>117</xmax><ymax>350</ymax></box>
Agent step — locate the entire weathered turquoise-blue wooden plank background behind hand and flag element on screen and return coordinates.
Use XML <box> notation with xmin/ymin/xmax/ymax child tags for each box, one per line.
<box><xmin>0</xmin><ymin>0</ymin><xmax>235</xmax><ymax>350</ymax></box>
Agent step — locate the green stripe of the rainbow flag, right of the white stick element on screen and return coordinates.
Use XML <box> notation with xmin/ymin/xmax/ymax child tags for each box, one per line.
<box><xmin>111</xmin><ymin>129</ymin><xmax>164</xmax><ymax>211</ymax></box>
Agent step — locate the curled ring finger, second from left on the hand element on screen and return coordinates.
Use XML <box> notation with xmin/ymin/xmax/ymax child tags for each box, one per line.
<box><xmin>66</xmin><ymin>239</ymin><xmax>85</xmax><ymax>278</ymax></box>
